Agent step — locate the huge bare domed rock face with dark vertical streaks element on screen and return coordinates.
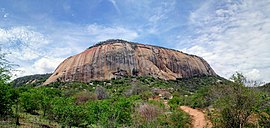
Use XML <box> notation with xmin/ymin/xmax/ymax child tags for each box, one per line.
<box><xmin>44</xmin><ymin>40</ymin><xmax>216</xmax><ymax>85</ymax></box>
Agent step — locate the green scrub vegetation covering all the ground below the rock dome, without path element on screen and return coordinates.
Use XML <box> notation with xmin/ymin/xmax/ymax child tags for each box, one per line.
<box><xmin>0</xmin><ymin>52</ymin><xmax>270</xmax><ymax>128</ymax></box>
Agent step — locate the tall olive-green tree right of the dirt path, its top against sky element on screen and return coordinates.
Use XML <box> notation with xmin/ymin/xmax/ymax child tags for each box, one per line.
<box><xmin>215</xmin><ymin>72</ymin><xmax>263</xmax><ymax>128</ymax></box>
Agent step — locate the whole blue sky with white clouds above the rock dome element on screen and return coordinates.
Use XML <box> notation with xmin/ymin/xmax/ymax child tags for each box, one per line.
<box><xmin>0</xmin><ymin>0</ymin><xmax>270</xmax><ymax>82</ymax></box>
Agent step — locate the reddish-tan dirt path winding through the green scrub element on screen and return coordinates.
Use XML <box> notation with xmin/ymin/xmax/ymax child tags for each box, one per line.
<box><xmin>180</xmin><ymin>106</ymin><xmax>212</xmax><ymax>128</ymax></box>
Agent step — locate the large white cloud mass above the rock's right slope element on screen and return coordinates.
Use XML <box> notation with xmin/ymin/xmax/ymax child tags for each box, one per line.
<box><xmin>181</xmin><ymin>0</ymin><xmax>270</xmax><ymax>82</ymax></box>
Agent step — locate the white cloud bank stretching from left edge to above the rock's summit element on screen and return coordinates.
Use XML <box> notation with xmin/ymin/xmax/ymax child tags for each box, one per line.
<box><xmin>0</xmin><ymin>24</ymin><xmax>138</xmax><ymax>78</ymax></box>
